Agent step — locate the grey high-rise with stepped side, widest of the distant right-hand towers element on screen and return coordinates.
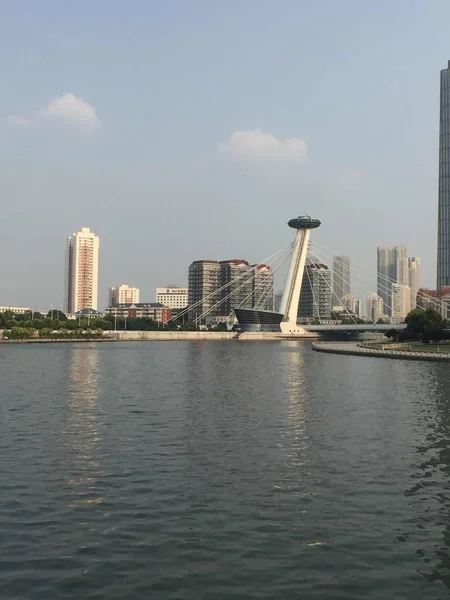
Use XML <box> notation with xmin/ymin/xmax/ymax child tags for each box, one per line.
<box><xmin>377</xmin><ymin>246</ymin><xmax>409</xmax><ymax>316</ymax></box>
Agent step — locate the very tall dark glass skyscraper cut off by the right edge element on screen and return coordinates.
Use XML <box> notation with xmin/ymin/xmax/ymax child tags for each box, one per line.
<box><xmin>437</xmin><ymin>61</ymin><xmax>450</xmax><ymax>290</ymax></box>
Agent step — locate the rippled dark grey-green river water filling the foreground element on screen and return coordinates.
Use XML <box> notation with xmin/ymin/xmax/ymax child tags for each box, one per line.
<box><xmin>0</xmin><ymin>341</ymin><xmax>450</xmax><ymax>600</ymax></box>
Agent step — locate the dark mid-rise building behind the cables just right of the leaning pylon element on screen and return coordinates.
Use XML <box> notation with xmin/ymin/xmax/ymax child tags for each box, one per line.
<box><xmin>298</xmin><ymin>263</ymin><xmax>332</xmax><ymax>320</ymax></box>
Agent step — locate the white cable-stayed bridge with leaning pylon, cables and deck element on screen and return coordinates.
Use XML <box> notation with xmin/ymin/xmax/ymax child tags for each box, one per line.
<box><xmin>175</xmin><ymin>216</ymin><xmax>439</xmax><ymax>337</ymax></box>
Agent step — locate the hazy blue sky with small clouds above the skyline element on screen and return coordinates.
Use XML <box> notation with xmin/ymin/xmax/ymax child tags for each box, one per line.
<box><xmin>0</xmin><ymin>0</ymin><xmax>450</xmax><ymax>308</ymax></box>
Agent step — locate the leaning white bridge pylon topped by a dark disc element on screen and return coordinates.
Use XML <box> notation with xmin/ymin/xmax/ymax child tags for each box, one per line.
<box><xmin>280</xmin><ymin>216</ymin><xmax>320</xmax><ymax>334</ymax></box>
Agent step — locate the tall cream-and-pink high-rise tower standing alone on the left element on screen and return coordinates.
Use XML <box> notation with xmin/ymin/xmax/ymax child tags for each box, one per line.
<box><xmin>64</xmin><ymin>227</ymin><xmax>100</xmax><ymax>313</ymax></box>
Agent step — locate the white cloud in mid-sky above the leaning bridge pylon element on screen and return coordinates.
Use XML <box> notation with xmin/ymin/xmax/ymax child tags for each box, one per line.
<box><xmin>219</xmin><ymin>129</ymin><xmax>308</xmax><ymax>162</ymax></box>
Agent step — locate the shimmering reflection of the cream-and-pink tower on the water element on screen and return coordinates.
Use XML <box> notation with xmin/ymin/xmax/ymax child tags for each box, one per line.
<box><xmin>66</xmin><ymin>344</ymin><xmax>103</xmax><ymax>505</ymax></box>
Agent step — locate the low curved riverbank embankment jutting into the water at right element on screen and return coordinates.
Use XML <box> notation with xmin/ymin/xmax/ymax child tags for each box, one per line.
<box><xmin>312</xmin><ymin>342</ymin><xmax>450</xmax><ymax>362</ymax></box>
